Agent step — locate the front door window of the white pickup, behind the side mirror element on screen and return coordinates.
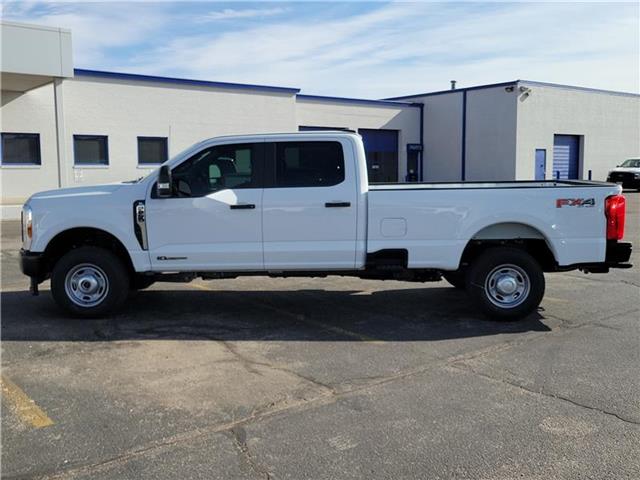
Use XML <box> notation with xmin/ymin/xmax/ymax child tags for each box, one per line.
<box><xmin>172</xmin><ymin>143</ymin><xmax>262</xmax><ymax>197</ymax></box>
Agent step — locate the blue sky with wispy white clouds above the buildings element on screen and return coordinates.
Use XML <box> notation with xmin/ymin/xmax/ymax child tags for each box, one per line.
<box><xmin>2</xmin><ymin>1</ymin><xmax>640</xmax><ymax>98</ymax></box>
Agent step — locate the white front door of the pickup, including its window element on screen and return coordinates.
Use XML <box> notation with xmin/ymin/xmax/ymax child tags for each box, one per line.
<box><xmin>147</xmin><ymin>143</ymin><xmax>264</xmax><ymax>271</ymax></box>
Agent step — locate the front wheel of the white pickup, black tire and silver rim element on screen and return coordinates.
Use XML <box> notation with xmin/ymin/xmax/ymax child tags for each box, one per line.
<box><xmin>51</xmin><ymin>247</ymin><xmax>130</xmax><ymax>318</ymax></box>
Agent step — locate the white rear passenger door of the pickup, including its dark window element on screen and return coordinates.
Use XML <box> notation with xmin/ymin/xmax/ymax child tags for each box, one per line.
<box><xmin>262</xmin><ymin>139</ymin><xmax>358</xmax><ymax>270</ymax></box>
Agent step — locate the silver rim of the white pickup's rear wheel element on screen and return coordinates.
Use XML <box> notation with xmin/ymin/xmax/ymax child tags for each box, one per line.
<box><xmin>484</xmin><ymin>265</ymin><xmax>531</xmax><ymax>308</ymax></box>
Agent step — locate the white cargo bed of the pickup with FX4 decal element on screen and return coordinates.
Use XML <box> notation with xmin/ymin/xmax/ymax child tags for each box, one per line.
<box><xmin>367</xmin><ymin>180</ymin><xmax>620</xmax><ymax>270</ymax></box>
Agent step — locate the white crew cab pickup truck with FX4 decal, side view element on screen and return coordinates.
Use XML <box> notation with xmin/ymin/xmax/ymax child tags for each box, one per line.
<box><xmin>21</xmin><ymin>132</ymin><xmax>631</xmax><ymax>319</ymax></box>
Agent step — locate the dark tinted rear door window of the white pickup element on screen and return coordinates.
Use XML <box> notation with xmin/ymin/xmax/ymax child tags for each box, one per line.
<box><xmin>276</xmin><ymin>142</ymin><xmax>344</xmax><ymax>187</ymax></box>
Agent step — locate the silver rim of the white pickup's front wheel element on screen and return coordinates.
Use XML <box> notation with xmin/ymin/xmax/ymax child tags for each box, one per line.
<box><xmin>64</xmin><ymin>263</ymin><xmax>109</xmax><ymax>308</ymax></box>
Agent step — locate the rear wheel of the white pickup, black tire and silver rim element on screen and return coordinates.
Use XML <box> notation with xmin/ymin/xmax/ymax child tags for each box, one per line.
<box><xmin>467</xmin><ymin>247</ymin><xmax>545</xmax><ymax>321</ymax></box>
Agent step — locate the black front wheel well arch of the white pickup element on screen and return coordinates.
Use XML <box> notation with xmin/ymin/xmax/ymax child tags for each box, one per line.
<box><xmin>44</xmin><ymin>227</ymin><xmax>135</xmax><ymax>274</ymax></box>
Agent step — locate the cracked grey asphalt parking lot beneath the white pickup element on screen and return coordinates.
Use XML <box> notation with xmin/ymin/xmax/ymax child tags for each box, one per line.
<box><xmin>1</xmin><ymin>193</ymin><xmax>640</xmax><ymax>479</ymax></box>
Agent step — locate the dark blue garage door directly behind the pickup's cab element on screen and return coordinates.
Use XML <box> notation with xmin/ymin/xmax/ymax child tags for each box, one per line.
<box><xmin>358</xmin><ymin>128</ymin><xmax>398</xmax><ymax>183</ymax></box>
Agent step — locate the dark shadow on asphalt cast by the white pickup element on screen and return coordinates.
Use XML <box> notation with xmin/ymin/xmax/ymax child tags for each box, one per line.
<box><xmin>1</xmin><ymin>288</ymin><xmax>551</xmax><ymax>342</ymax></box>
